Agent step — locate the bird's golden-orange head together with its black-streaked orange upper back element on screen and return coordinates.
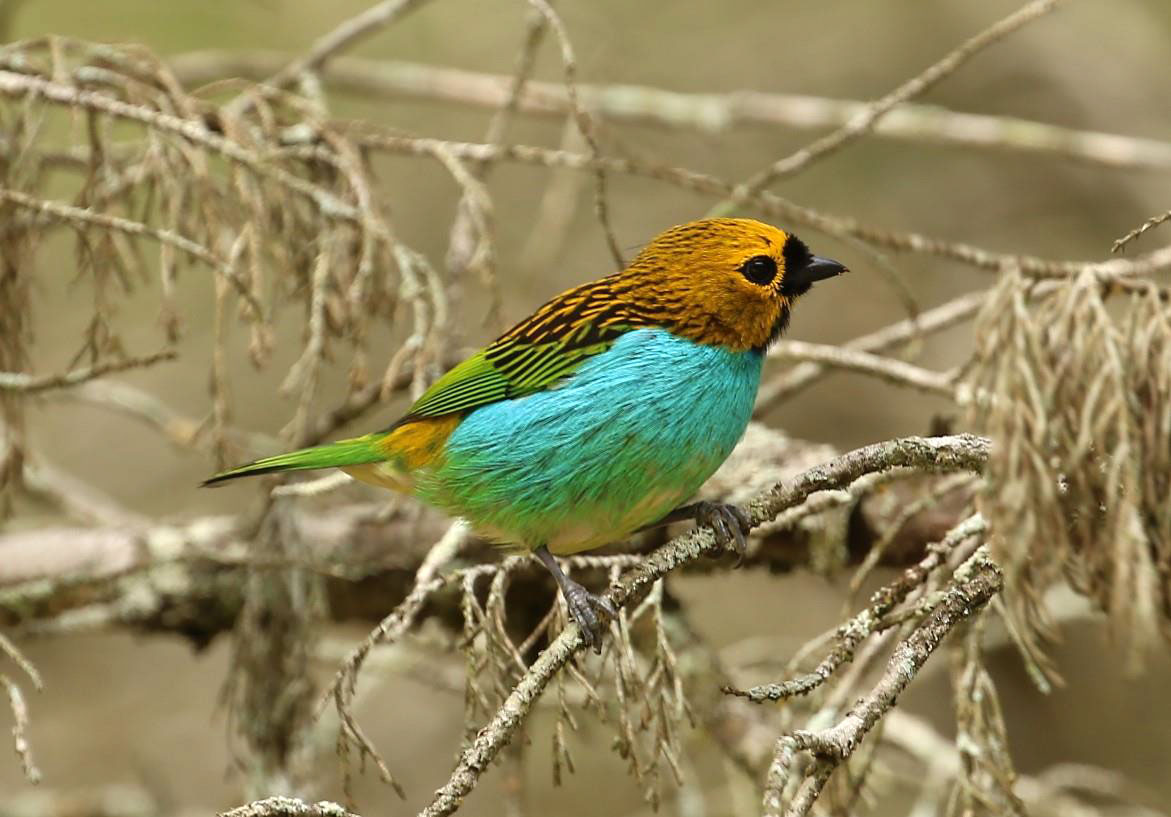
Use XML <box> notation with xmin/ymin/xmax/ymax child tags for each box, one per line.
<box><xmin>488</xmin><ymin>219</ymin><xmax>845</xmax><ymax>357</ymax></box>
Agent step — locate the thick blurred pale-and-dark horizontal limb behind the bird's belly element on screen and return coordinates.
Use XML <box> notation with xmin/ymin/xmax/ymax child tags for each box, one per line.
<box><xmin>0</xmin><ymin>424</ymin><xmax>958</xmax><ymax>645</ymax></box>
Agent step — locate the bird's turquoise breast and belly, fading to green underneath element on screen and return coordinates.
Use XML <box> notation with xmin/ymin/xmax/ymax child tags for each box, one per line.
<box><xmin>416</xmin><ymin>329</ymin><xmax>762</xmax><ymax>554</ymax></box>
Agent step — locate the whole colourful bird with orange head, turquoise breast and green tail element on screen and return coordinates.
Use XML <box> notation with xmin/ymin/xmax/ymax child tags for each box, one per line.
<box><xmin>204</xmin><ymin>218</ymin><xmax>847</xmax><ymax>651</ymax></box>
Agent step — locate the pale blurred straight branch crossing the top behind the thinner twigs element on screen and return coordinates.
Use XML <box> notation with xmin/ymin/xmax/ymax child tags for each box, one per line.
<box><xmin>170</xmin><ymin>49</ymin><xmax>1171</xmax><ymax>170</ymax></box>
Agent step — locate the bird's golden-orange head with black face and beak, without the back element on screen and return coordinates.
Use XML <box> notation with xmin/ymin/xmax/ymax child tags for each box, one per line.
<box><xmin>615</xmin><ymin>219</ymin><xmax>845</xmax><ymax>351</ymax></box>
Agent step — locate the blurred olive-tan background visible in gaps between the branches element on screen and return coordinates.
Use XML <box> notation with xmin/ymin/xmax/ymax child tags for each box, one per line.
<box><xmin>0</xmin><ymin>0</ymin><xmax>1171</xmax><ymax>815</ymax></box>
